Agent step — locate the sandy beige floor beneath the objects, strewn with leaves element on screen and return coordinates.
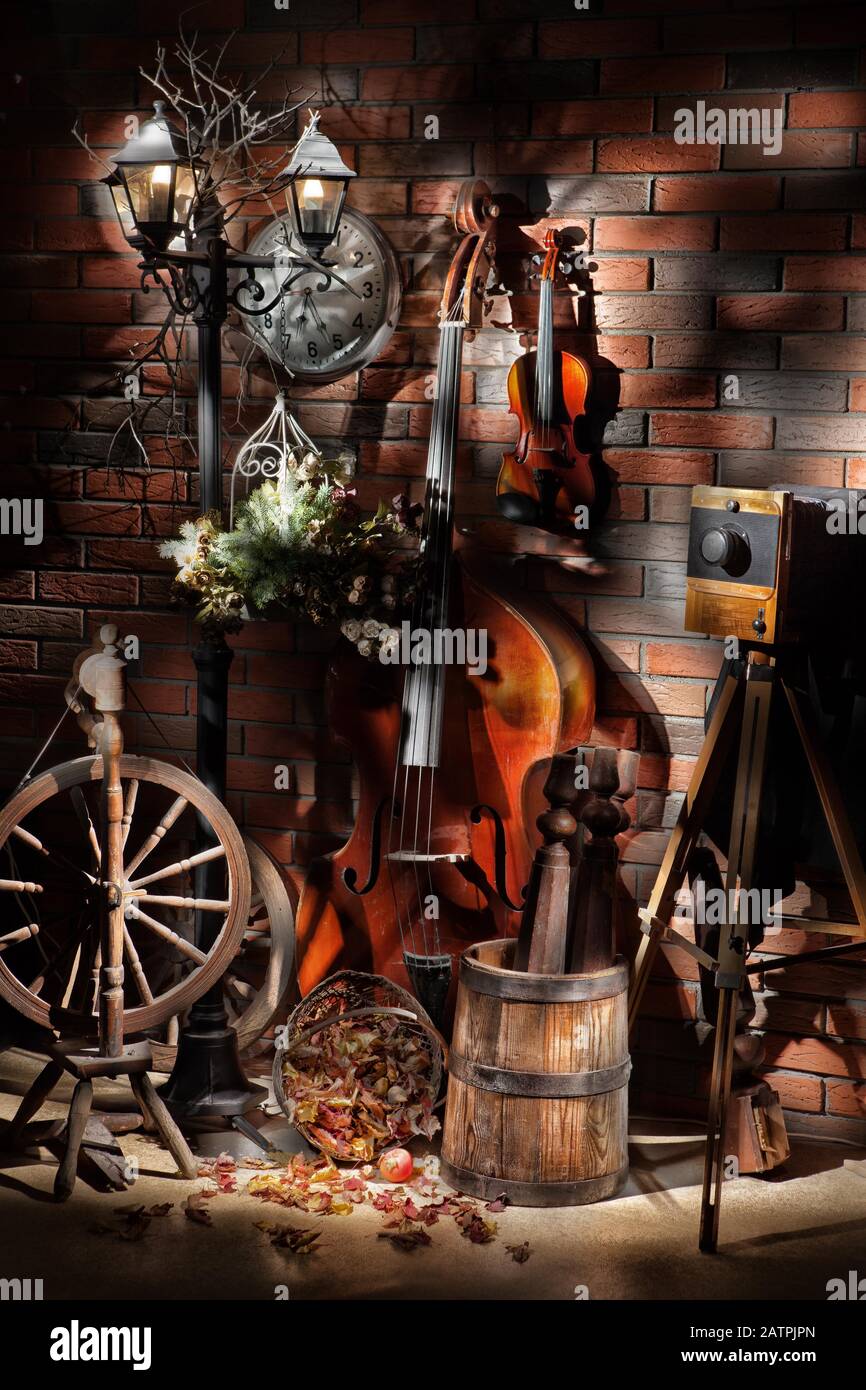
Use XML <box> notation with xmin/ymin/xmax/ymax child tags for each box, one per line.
<box><xmin>0</xmin><ymin>1052</ymin><xmax>866</xmax><ymax>1301</ymax></box>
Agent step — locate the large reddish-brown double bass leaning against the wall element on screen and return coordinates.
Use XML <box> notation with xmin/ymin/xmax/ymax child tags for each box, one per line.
<box><xmin>296</xmin><ymin>181</ymin><xmax>595</xmax><ymax>1023</ymax></box>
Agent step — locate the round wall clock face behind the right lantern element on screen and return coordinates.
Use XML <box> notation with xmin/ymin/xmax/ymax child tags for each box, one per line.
<box><xmin>242</xmin><ymin>210</ymin><xmax>400</xmax><ymax>381</ymax></box>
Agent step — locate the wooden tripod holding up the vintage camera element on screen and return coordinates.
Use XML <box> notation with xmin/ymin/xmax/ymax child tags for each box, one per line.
<box><xmin>628</xmin><ymin>646</ymin><xmax>866</xmax><ymax>1252</ymax></box>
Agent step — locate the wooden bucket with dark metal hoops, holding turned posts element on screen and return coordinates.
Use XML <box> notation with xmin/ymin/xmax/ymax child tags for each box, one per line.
<box><xmin>442</xmin><ymin>940</ymin><xmax>631</xmax><ymax>1207</ymax></box>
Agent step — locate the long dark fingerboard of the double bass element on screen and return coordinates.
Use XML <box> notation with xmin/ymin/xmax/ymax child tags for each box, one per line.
<box><xmin>400</xmin><ymin>318</ymin><xmax>464</xmax><ymax>767</ymax></box>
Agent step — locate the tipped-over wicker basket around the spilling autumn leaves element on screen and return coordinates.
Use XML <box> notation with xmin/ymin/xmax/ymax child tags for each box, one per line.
<box><xmin>274</xmin><ymin>970</ymin><xmax>448</xmax><ymax>1158</ymax></box>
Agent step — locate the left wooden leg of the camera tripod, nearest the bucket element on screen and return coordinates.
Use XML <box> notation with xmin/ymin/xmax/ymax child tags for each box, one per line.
<box><xmin>628</xmin><ymin>661</ymin><xmax>745</xmax><ymax>1031</ymax></box>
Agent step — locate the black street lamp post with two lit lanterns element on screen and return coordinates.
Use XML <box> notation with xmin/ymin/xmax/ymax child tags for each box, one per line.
<box><xmin>104</xmin><ymin>101</ymin><xmax>354</xmax><ymax>1120</ymax></box>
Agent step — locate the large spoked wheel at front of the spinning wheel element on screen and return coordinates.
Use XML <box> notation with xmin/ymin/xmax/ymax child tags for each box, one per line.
<box><xmin>0</xmin><ymin>755</ymin><xmax>250</xmax><ymax>1037</ymax></box>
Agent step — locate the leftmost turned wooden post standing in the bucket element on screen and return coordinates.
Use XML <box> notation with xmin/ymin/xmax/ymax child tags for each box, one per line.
<box><xmin>514</xmin><ymin>753</ymin><xmax>577</xmax><ymax>974</ymax></box>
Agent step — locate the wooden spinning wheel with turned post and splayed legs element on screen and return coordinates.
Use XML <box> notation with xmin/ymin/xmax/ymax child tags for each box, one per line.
<box><xmin>0</xmin><ymin>626</ymin><xmax>250</xmax><ymax>1200</ymax></box>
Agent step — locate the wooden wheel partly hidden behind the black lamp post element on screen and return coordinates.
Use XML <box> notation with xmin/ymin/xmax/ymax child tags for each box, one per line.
<box><xmin>152</xmin><ymin>835</ymin><xmax>297</xmax><ymax>1072</ymax></box>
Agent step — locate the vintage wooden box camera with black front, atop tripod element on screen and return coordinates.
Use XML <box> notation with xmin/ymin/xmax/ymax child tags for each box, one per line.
<box><xmin>685</xmin><ymin>487</ymin><xmax>866</xmax><ymax>644</ymax></box>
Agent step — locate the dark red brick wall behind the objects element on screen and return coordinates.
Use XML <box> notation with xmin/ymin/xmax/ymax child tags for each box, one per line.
<box><xmin>0</xmin><ymin>0</ymin><xmax>866</xmax><ymax>1137</ymax></box>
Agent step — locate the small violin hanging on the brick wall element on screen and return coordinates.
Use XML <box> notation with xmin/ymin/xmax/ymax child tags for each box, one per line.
<box><xmin>496</xmin><ymin>229</ymin><xmax>595</xmax><ymax>531</ymax></box>
